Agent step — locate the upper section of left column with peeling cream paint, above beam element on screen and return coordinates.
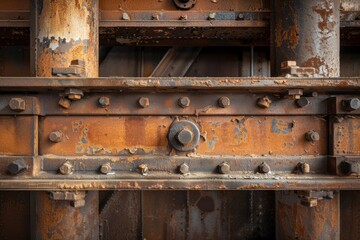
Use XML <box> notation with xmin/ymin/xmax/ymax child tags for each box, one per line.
<box><xmin>32</xmin><ymin>0</ymin><xmax>98</xmax><ymax>77</ymax></box>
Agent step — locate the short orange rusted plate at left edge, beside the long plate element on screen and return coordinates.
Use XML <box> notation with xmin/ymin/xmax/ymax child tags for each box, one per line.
<box><xmin>0</xmin><ymin>116</ymin><xmax>37</xmax><ymax>156</ymax></box>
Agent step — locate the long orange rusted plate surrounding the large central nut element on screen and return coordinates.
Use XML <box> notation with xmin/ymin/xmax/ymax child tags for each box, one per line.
<box><xmin>39</xmin><ymin>116</ymin><xmax>327</xmax><ymax>156</ymax></box>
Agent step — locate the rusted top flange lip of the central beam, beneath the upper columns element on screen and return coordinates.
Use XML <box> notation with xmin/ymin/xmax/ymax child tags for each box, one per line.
<box><xmin>0</xmin><ymin>77</ymin><xmax>360</xmax><ymax>93</ymax></box>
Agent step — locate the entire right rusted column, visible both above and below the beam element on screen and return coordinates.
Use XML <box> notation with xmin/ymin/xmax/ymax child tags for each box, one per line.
<box><xmin>271</xmin><ymin>0</ymin><xmax>340</xmax><ymax>239</ymax></box>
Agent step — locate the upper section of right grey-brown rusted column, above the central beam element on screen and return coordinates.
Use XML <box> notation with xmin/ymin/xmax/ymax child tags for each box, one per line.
<box><xmin>271</xmin><ymin>0</ymin><xmax>340</xmax><ymax>77</ymax></box>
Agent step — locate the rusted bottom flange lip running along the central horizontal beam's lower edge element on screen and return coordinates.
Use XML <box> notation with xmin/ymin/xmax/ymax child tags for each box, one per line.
<box><xmin>0</xmin><ymin>178</ymin><xmax>360</xmax><ymax>191</ymax></box>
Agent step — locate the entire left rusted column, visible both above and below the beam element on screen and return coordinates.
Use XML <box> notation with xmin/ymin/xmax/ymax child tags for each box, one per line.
<box><xmin>31</xmin><ymin>0</ymin><xmax>99</xmax><ymax>239</ymax></box>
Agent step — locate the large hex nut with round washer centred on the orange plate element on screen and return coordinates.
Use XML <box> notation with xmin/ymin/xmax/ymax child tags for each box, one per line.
<box><xmin>168</xmin><ymin>120</ymin><xmax>200</xmax><ymax>152</ymax></box>
